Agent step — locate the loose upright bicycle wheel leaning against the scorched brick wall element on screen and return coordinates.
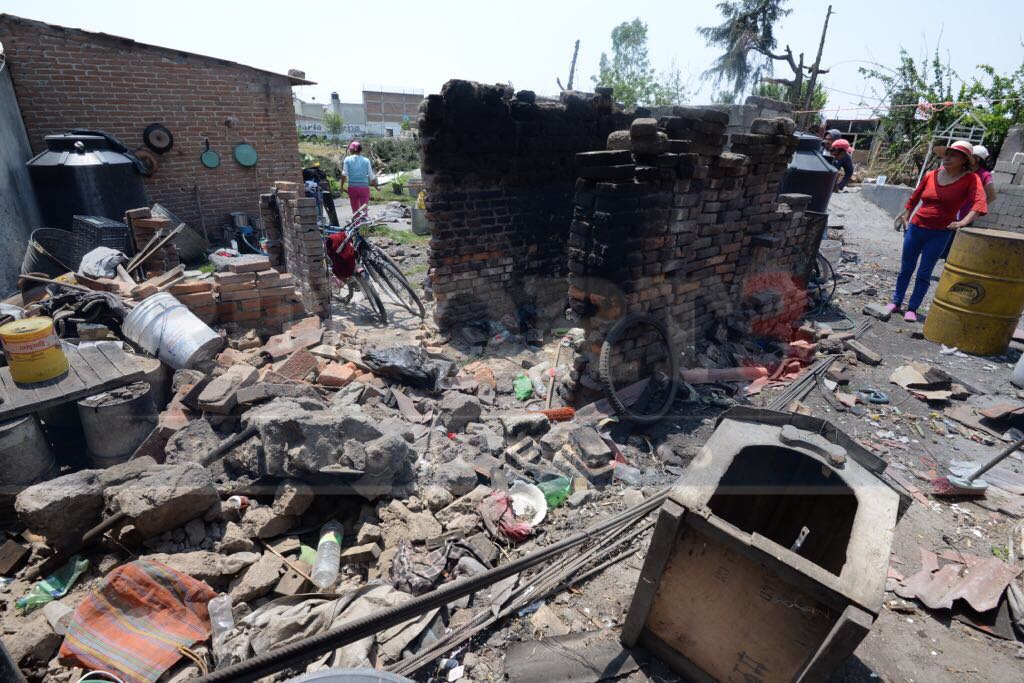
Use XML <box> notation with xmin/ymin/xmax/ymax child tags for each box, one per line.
<box><xmin>598</xmin><ymin>313</ymin><xmax>679</xmax><ymax>424</ymax></box>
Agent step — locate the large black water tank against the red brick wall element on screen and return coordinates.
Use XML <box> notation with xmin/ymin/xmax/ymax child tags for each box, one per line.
<box><xmin>28</xmin><ymin>133</ymin><xmax>150</xmax><ymax>229</ymax></box>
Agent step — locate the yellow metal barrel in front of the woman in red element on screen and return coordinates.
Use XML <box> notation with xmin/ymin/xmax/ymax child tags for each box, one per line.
<box><xmin>925</xmin><ymin>227</ymin><xmax>1024</xmax><ymax>355</ymax></box>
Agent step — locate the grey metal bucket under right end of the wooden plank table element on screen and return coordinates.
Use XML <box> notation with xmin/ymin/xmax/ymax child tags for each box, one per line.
<box><xmin>78</xmin><ymin>382</ymin><xmax>157</xmax><ymax>468</ymax></box>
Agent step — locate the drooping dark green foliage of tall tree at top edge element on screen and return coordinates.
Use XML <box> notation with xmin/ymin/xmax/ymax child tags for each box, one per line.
<box><xmin>697</xmin><ymin>0</ymin><xmax>792</xmax><ymax>93</ymax></box>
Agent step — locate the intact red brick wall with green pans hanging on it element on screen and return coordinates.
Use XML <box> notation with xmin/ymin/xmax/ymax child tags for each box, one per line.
<box><xmin>0</xmin><ymin>15</ymin><xmax>301</xmax><ymax>237</ymax></box>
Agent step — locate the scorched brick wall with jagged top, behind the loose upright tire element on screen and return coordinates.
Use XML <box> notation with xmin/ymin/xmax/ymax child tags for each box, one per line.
<box><xmin>569</xmin><ymin>112</ymin><xmax>809</xmax><ymax>388</ymax></box>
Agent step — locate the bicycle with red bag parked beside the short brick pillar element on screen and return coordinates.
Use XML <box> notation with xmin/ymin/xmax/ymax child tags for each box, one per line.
<box><xmin>321</xmin><ymin>206</ymin><xmax>427</xmax><ymax>325</ymax></box>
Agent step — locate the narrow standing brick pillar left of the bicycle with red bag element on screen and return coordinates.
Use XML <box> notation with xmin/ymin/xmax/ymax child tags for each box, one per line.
<box><xmin>274</xmin><ymin>181</ymin><xmax>331</xmax><ymax>318</ymax></box>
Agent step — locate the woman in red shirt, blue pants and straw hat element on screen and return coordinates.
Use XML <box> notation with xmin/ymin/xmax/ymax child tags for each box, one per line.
<box><xmin>888</xmin><ymin>140</ymin><xmax>988</xmax><ymax>323</ymax></box>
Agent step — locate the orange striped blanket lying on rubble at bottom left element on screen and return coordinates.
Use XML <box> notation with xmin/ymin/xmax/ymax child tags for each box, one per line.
<box><xmin>60</xmin><ymin>560</ymin><xmax>217</xmax><ymax>683</ymax></box>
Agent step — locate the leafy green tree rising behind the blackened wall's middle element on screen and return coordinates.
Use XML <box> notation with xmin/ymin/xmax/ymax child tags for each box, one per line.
<box><xmin>591</xmin><ymin>18</ymin><xmax>687</xmax><ymax>106</ymax></box>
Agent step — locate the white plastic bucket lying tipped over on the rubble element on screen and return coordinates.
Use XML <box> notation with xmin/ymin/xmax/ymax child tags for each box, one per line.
<box><xmin>121</xmin><ymin>292</ymin><xmax>223</xmax><ymax>370</ymax></box>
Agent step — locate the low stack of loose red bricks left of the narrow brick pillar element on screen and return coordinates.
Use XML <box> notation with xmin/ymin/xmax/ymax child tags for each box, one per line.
<box><xmin>213</xmin><ymin>256</ymin><xmax>306</xmax><ymax>334</ymax></box>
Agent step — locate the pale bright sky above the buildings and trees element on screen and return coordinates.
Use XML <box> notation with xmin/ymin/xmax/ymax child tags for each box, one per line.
<box><xmin>0</xmin><ymin>0</ymin><xmax>1024</xmax><ymax>119</ymax></box>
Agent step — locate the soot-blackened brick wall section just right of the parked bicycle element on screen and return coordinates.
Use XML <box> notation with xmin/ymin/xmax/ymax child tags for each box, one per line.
<box><xmin>419</xmin><ymin>81</ymin><xmax>633</xmax><ymax>328</ymax></box>
